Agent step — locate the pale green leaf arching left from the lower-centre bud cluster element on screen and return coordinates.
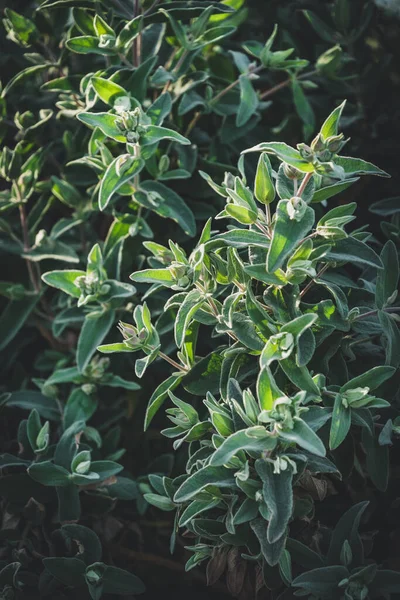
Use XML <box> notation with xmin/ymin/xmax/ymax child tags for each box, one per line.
<box><xmin>210</xmin><ymin>426</ymin><xmax>276</xmax><ymax>467</ymax></box>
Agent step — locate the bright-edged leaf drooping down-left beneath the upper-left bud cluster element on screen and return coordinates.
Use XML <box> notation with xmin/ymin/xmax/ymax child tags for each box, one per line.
<box><xmin>99</xmin><ymin>154</ymin><xmax>144</xmax><ymax>210</ymax></box>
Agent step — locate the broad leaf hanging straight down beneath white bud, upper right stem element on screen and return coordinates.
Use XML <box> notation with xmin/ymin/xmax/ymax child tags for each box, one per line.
<box><xmin>267</xmin><ymin>200</ymin><xmax>314</xmax><ymax>273</ymax></box>
